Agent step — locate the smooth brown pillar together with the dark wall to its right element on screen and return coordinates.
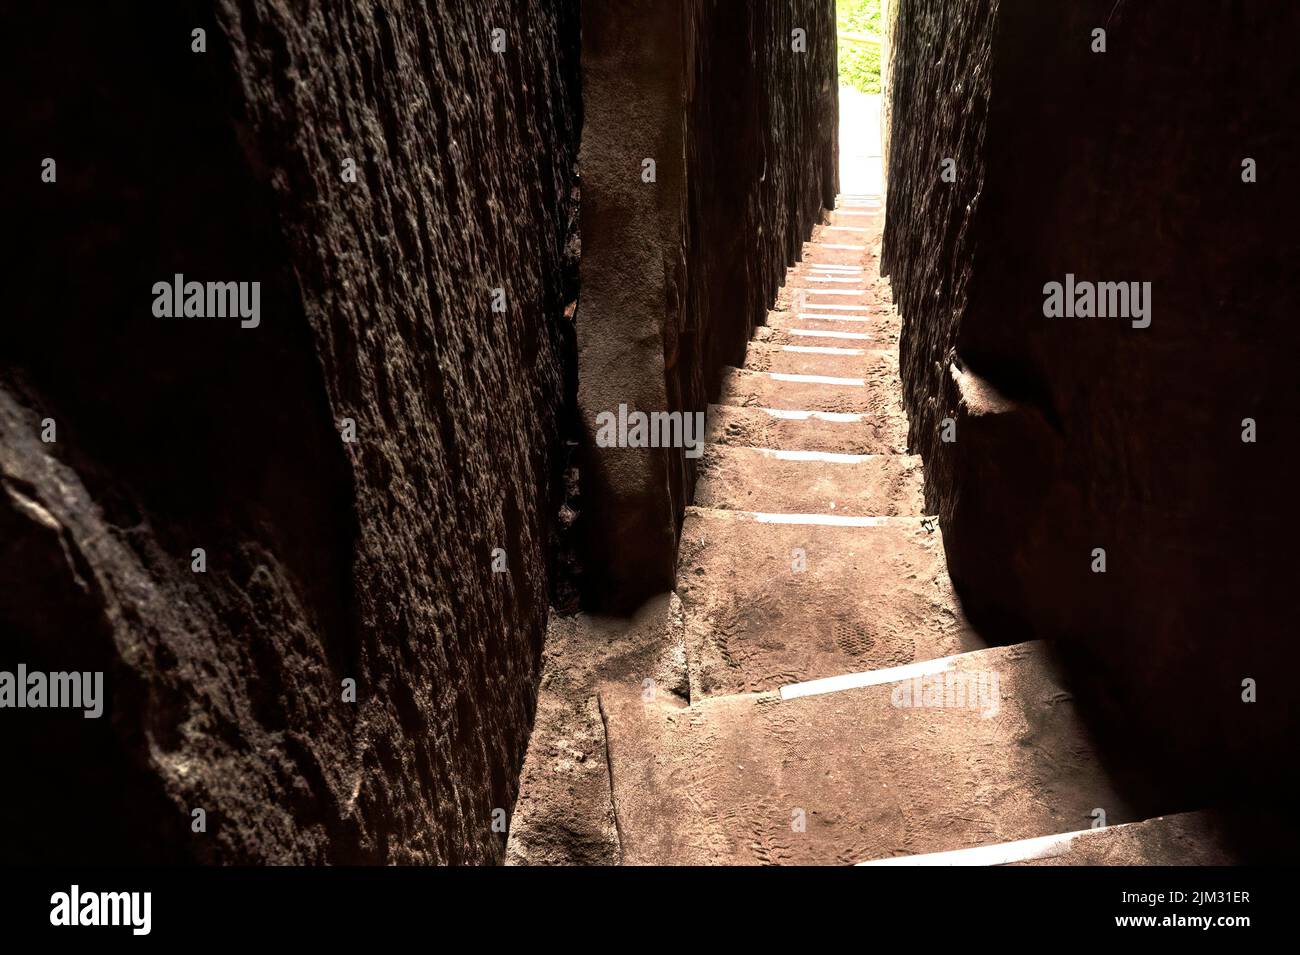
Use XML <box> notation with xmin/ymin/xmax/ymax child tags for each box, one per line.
<box><xmin>577</xmin><ymin>0</ymin><xmax>839</xmax><ymax>609</ymax></box>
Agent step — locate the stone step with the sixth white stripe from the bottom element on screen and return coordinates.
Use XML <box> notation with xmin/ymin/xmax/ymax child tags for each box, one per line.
<box><xmin>718</xmin><ymin>361</ymin><xmax>902</xmax><ymax>417</ymax></box>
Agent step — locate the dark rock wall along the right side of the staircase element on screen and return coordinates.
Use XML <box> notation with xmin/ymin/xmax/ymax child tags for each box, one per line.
<box><xmin>887</xmin><ymin>0</ymin><xmax>1300</xmax><ymax>795</ymax></box>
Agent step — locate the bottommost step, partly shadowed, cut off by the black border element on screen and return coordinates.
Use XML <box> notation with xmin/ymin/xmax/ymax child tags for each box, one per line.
<box><xmin>858</xmin><ymin>812</ymin><xmax>1240</xmax><ymax>865</ymax></box>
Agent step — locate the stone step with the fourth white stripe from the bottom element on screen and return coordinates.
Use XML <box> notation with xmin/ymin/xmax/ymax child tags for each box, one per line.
<box><xmin>696</xmin><ymin>444</ymin><xmax>924</xmax><ymax>516</ymax></box>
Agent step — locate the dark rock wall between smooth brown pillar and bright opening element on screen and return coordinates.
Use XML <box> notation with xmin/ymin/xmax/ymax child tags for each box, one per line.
<box><xmin>668</xmin><ymin>0</ymin><xmax>840</xmax><ymax>441</ymax></box>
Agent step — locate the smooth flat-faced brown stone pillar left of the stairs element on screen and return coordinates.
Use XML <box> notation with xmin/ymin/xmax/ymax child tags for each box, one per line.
<box><xmin>577</xmin><ymin>0</ymin><xmax>686</xmax><ymax>603</ymax></box>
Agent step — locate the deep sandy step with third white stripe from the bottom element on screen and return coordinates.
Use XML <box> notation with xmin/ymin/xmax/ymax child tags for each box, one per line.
<box><xmin>677</xmin><ymin>507</ymin><xmax>982</xmax><ymax>699</ymax></box>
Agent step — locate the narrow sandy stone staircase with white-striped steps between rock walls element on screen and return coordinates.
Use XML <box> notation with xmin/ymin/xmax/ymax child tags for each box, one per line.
<box><xmin>599</xmin><ymin>197</ymin><xmax>1216</xmax><ymax>864</ymax></box>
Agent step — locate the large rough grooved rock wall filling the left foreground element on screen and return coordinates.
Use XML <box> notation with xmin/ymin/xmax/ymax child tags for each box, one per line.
<box><xmin>0</xmin><ymin>0</ymin><xmax>580</xmax><ymax>863</ymax></box>
